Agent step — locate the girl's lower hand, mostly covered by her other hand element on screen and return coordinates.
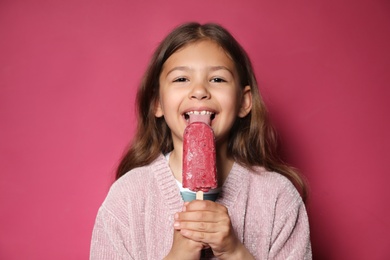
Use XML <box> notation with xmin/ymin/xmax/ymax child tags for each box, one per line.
<box><xmin>164</xmin><ymin>230</ymin><xmax>203</xmax><ymax>260</ymax></box>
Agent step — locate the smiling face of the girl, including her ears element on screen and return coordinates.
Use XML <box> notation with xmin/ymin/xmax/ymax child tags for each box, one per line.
<box><xmin>155</xmin><ymin>40</ymin><xmax>251</xmax><ymax>147</ymax></box>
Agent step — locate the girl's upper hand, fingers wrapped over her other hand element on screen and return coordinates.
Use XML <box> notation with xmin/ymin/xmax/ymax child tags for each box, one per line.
<box><xmin>174</xmin><ymin>200</ymin><xmax>252</xmax><ymax>259</ymax></box>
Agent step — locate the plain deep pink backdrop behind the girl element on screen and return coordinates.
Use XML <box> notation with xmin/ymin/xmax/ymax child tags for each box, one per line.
<box><xmin>0</xmin><ymin>0</ymin><xmax>390</xmax><ymax>260</ymax></box>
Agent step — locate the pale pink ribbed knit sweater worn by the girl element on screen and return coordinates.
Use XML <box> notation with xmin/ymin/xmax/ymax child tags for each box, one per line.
<box><xmin>90</xmin><ymin>155</ymin><xmax>312</xmax><ymax>260</ymax></box>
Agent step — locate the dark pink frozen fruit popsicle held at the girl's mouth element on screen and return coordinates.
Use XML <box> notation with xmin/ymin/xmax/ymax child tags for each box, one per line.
<box><xmin>183</xmin><ymin>122</ymin><xmax>217</xmax><ymax>192</ymax></box>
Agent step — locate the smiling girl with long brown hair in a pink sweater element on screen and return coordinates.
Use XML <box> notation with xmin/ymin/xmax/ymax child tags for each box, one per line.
<box><xmin>91</xmin><ymin>23</ymin><xmax>311</xmax><ymax>259</ymax></box>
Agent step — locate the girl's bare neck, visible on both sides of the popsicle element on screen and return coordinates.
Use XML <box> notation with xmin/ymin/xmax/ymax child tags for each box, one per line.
<box><xmin>169</xmin><ymin>142</ymin><xmax>234</xmax><ymax>186</ymax></box>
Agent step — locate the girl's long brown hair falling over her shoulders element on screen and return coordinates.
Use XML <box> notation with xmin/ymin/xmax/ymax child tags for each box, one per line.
<box><xmin>116</xmin><ymin>23</ymin><xmax>307</xmax><ymax>199</ymax></box>
